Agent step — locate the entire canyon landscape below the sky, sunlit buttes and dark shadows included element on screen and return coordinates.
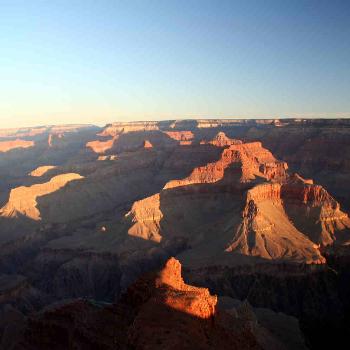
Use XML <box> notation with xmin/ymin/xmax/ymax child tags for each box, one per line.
<box><xmin>0</xmin><ymin>119</ymin><xmax>350</xmax><ymax>349</ymax></box>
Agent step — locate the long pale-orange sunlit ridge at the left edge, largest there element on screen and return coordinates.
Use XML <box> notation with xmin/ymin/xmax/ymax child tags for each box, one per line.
<box><xmin>0</xmin><ymin>173</ymin><xmax>83</xmax><ymax>220</ymax></box>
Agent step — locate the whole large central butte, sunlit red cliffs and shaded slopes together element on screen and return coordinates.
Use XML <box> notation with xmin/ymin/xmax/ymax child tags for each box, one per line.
<box><xmin>126</xmin><ymin>139</ymin><xmax>348</xmax><ymax>266</ymax></box>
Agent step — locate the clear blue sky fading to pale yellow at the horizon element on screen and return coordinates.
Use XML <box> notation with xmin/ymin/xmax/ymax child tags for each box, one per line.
<box><xmin>0</xmin><ymin>0</ymin><xmax>350</xmax><ymax>128</ymax></box>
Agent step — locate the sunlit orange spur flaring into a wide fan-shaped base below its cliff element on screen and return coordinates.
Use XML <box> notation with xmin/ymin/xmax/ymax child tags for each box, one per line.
<box><xmin>226</xmin><ymin>184</ymin><xmax>325</xmax><ymax>264</ymax></box>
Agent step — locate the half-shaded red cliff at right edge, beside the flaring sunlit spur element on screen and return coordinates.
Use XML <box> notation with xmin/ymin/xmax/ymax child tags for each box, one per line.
<box><xmin>281</xmin><ymin>174</ymin><xmax>350</xmax><ymax>246</ymax></box>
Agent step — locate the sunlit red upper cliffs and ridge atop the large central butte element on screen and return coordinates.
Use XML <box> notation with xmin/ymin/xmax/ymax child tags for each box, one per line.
<box><xmin>164</xmin><ymin>142</ymin><xmax>287</xmax><ymax>189</ymax></box>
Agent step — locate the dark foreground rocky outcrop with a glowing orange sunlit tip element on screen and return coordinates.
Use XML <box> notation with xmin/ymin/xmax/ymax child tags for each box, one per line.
<box><xmin>7</xmin><ymin>259</ymin><xmax>304</xmax><ymax>350</ymax></box>
